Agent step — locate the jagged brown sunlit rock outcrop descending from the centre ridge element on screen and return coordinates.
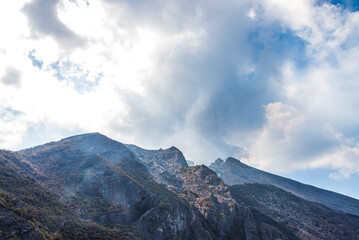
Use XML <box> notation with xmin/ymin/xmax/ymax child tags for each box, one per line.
<box><xmin>177</xmin><ymin>165</ymin><xmax>304</xmax><ymax>239</ymax></box>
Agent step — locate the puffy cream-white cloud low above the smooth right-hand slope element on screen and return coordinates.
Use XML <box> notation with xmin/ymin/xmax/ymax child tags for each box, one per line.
<box><xmin>246</xmin><ymin>102</ymin><xmax>359</xmax><ymax>178</ymax></box>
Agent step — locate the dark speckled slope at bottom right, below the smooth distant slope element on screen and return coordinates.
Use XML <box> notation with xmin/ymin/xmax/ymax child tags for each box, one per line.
<box><xmin>229</xmin><ymin>184</ymin><xmax>359</xmax><ymax>240</ymax></box>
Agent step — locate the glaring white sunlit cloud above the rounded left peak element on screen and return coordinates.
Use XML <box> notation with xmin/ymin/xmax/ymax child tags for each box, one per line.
<box><xmin>0</xmin><ymin>1</ymin><xmax>202</xmax><ymax>148</ymax></box>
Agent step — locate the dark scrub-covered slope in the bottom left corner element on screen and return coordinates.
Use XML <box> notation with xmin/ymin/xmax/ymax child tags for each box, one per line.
<box><xmin>0</xmin><ymin>148</ymin><xmax>138</xmax><ymax>239</ymax></box>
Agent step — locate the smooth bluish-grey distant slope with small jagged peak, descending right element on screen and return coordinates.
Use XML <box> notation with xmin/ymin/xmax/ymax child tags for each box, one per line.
<box><xmin>209</xmin><ymin>157</ymin><xmax>359</xmax><ymax>216</ymax></box>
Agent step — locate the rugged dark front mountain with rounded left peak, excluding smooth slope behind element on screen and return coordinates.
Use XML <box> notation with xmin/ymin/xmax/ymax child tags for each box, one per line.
<box><xmin>0</xmin><ymin>133</ymin><xmax>359</xmax><ymax>239</ymax></box>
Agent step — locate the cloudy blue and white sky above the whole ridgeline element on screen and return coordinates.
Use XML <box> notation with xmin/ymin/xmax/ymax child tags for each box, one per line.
<box><xmin>0</xmin><ymin>0</ymin><xmax>359</xmax><ymax>198</ymax></box>
